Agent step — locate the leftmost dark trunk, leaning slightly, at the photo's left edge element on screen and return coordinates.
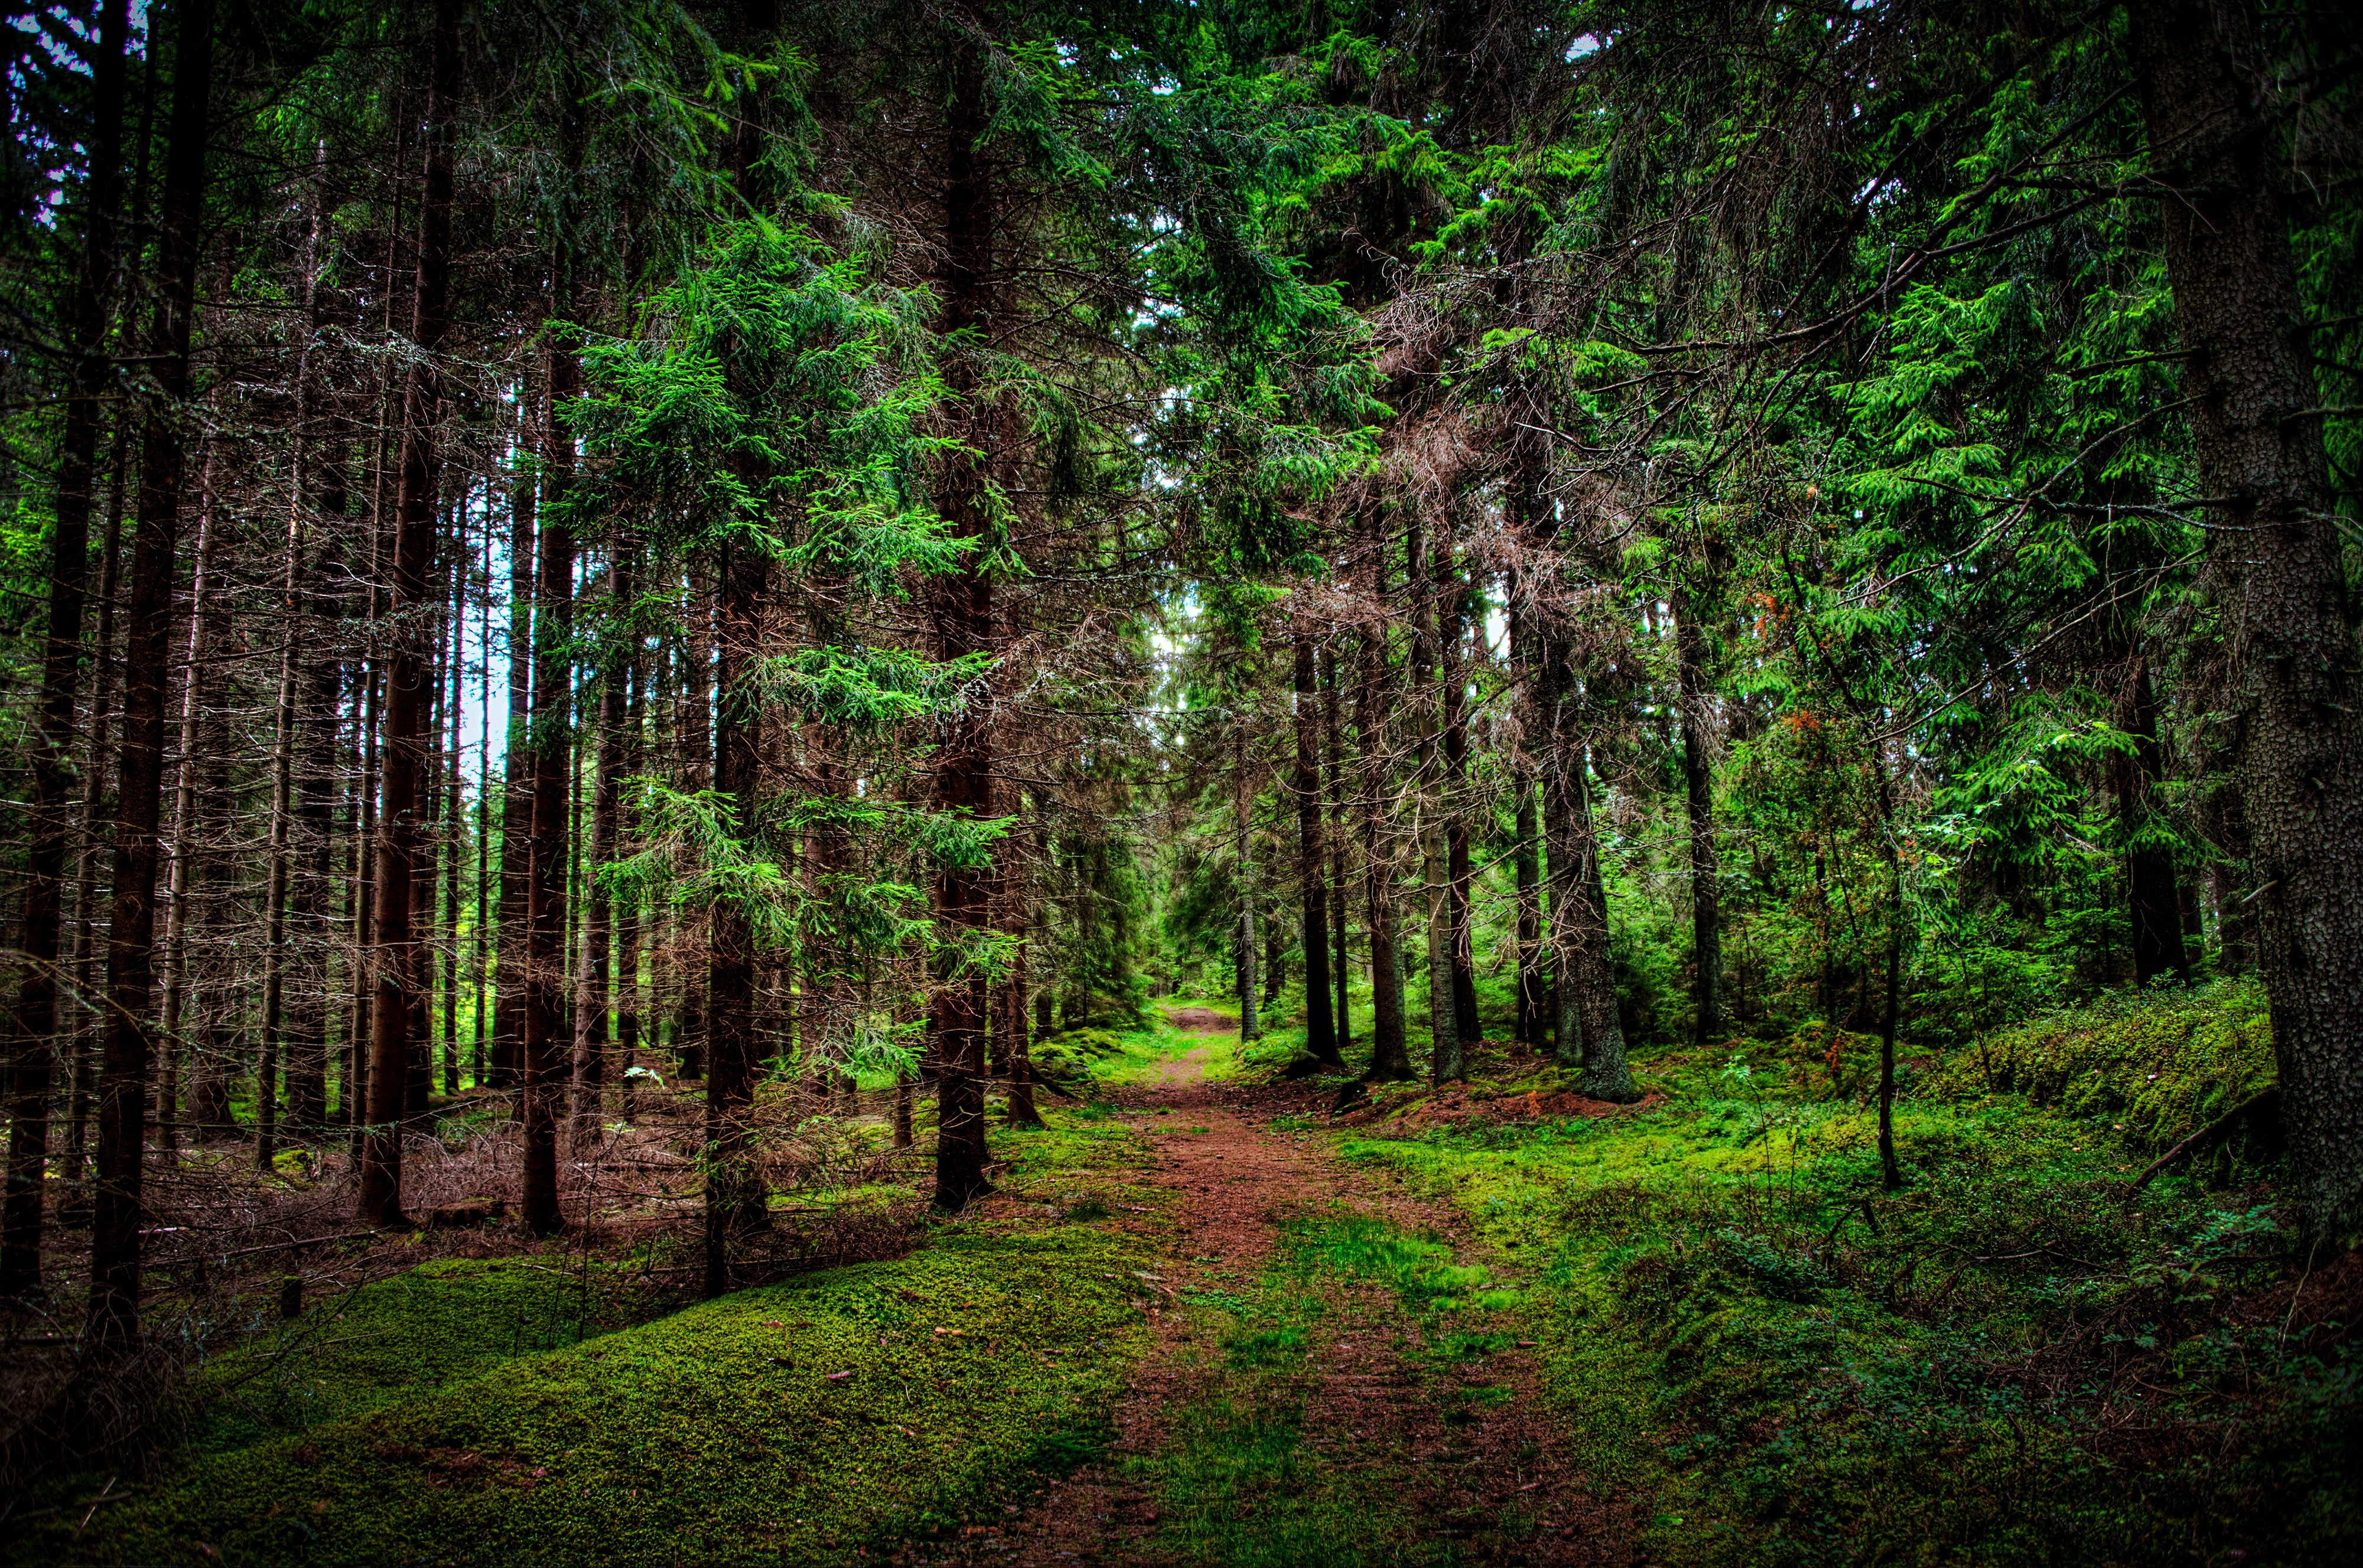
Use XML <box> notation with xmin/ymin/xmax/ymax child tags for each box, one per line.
<box><xmin>0</xmin><ymin>0</ymin><xmax>128</xmax><ymax>1296</ymax></box>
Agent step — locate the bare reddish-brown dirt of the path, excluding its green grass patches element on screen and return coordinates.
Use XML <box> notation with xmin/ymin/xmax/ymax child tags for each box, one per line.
<box><xmin>931</xmin><ymin>1046</ymin><xmax>1633</xmax><ymax>1568</ymax></box>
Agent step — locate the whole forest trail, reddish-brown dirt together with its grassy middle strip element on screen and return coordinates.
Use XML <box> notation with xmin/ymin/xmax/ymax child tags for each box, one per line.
<box><xmin>931</xmin><ymin>1046</ymin><xmax>1638</xmax><ymax>1568</ymax></box>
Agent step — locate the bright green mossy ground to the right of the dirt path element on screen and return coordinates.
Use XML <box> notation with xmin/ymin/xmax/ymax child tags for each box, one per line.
<box><xmin>1340</xmin><ymin>985</ymin><xmax>2363</xmax><ymax>1563</ymax></box>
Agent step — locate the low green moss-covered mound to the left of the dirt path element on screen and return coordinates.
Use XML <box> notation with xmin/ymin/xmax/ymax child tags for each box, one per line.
<box><xmin>7</xmin><ymin>1112</ymin><xmax>1160</xmax><ymax>1568</ymax></box>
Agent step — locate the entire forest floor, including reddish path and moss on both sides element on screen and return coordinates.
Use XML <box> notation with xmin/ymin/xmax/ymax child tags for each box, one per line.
<box><xmin>14</xmin><ymin>985</ymin><xmax>2363</xmax><ymax>1568</ymax></box>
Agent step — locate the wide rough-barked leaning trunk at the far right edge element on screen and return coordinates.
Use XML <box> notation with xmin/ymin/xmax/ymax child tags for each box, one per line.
<box><xmin>2127</xmin><ymin>0</ymin><xmax>2363</xmax><ymax>1240</ymax></box>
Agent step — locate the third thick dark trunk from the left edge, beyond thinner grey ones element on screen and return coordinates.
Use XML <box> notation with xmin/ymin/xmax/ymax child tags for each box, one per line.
<box><xmin>359</xmin><ymin>0</ymin><xmax>461</xmax><ymax>1225</ymax></box>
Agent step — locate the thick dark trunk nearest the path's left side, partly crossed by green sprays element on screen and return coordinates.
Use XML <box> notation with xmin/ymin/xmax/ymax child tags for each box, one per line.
<box><xmin>929</xmin><ymin>35</ymin><xmax>997</xmax><ymax>1211</ymax></box>
